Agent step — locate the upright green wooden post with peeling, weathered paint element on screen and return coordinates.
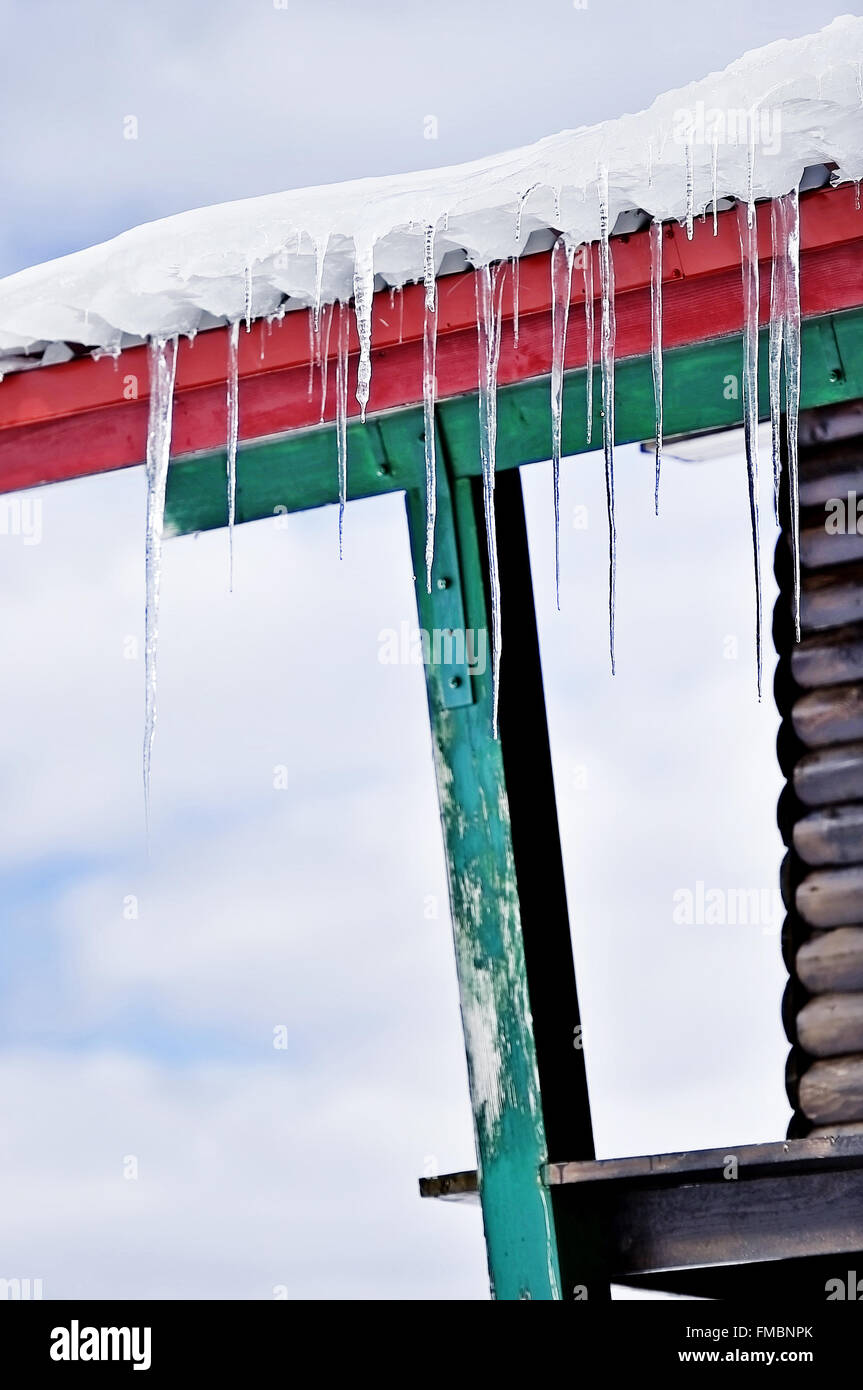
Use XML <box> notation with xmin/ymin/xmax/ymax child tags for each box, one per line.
<box><xmin>381</xmin><ymin>416</ymin><xmax>560</xmax><ymax>1300</ymax></box>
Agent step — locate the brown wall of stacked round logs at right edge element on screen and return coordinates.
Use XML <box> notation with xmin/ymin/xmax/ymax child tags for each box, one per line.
<box><xmin>774</xmin><ymin>403</ymin><xmax>863</xmax><ymax>1138</ymax></box>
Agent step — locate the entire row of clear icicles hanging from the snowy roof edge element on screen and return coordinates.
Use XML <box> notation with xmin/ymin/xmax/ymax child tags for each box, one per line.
<box><xmin>143</xmin><ymin>172</ymin><xmax>800</xmax><ymax>826</ymax></box>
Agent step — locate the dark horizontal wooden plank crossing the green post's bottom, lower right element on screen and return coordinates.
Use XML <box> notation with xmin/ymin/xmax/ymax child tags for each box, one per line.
<box><xmin>420</xmin><ymin>1134</ymin><xmax>863</xmax><ymax>1287</ymax></box>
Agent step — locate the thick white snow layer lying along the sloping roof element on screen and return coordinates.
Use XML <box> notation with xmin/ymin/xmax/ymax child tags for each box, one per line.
<box><xmin>0</xmin><ymin>15</ymin><xmax>863</xmax><ymax>370</ymax></box>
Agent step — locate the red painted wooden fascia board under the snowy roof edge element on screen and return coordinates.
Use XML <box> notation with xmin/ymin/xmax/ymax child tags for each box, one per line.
<box><xmin>0</xmin><ymin>186</ymin><xmax>863</xmax><ymax>492</ymax></box>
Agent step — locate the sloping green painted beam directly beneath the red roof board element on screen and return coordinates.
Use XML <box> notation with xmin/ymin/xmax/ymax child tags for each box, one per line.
<box><xmin>167</xmin><ymin>310</ymin><xmax>863</xmax><ymax>535</ymax></box>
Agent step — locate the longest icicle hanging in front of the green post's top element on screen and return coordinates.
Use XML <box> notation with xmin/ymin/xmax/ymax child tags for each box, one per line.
<box><xmin>474</xmin><ymin>265</ymin><xmax>503</xmax><ymax>738</ymax></box>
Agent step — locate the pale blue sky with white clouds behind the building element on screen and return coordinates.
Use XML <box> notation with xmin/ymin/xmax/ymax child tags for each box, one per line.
<box><xmin>0</xmin><ymin>0</ymin><xmax>834</xmax><ymax>1298</ymax></box>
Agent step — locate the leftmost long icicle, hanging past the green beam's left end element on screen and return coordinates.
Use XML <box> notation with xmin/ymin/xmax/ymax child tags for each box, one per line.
<box><xmin>143</xmin><ymin>338</ymin><xmax>176</xmax><ymax>837</ymax></box>
